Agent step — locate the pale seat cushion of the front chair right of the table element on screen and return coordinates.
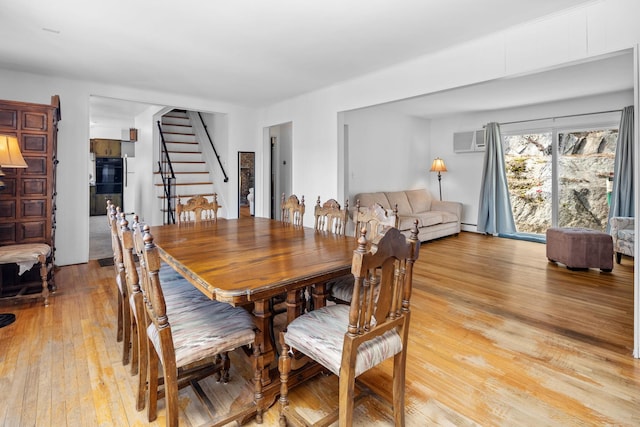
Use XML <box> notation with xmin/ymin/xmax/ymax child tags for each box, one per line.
<box><xmin>284</xmin><ymin>304</ymin><xmax>402</xmax><ymax>376</ymax></box>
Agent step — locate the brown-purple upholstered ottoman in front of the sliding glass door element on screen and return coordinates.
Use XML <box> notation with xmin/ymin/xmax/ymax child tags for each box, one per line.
<box><xmin>547</xmin><ymin>228</ymin><xmax>613</xmax><ymax>272</ymax></box>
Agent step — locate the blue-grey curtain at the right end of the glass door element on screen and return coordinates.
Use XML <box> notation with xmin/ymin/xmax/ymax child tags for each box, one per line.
<box><xmin>607</xmin><ymin>105</ymin><xmax>634</xmax><ymax>226</ymax></box>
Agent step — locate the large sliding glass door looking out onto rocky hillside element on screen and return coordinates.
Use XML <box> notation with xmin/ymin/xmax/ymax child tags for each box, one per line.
<box><xmin>503</xmin><ymin>126</ymin><xmax>618</xmax><ymax>234</ymax></box>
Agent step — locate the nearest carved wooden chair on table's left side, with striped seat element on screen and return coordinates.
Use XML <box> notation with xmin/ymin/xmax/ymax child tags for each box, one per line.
<box><xmin>140</xmin><ymin>225</ymin><xmax>262</xmax><ymax>426</ymax></box>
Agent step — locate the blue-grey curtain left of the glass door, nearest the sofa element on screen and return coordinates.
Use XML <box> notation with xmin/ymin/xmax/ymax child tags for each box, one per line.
<box><xmin>478</xmin><ymin>123</ymin><xmax>516</xmax><ymax>234</ymax></box>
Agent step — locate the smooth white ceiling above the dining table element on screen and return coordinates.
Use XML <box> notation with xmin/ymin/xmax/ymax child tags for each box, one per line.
<box><xmin>0</xmin><ymin>0</ymin><xmax>593</xmax><ymax>107</ymax></box>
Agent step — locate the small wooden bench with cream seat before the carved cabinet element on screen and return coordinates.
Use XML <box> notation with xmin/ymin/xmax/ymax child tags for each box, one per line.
<box><xmin>0</xmin><ymin>243</ymin><xmax>55</xmax><ymax>306</ymax></box>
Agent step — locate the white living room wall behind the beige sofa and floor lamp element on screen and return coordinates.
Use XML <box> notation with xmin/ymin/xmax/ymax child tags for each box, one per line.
<box><xmin>340</xmin><ymin>89</ymin><xmax>633</xmax><ymax>227</ymax></box>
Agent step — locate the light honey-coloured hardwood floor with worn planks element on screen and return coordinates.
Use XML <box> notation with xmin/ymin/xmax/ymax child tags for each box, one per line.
<box><xmin>0</xmin><ymin>233</ymin><xmax>640</xmax><ymax>426</ymax></box>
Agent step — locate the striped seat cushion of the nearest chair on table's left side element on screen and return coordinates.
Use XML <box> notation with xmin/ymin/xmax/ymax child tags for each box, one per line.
<box><xmin>147</xmin><ymin>287</ymin><xmax>255</xmax><ymax>367</ymax></box>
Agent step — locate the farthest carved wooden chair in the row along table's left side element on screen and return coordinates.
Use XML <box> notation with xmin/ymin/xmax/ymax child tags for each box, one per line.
<box><xmin>107</xmin><ymin>203</ymin><xmax>130</xmax><ymax>369</ymax></box>
